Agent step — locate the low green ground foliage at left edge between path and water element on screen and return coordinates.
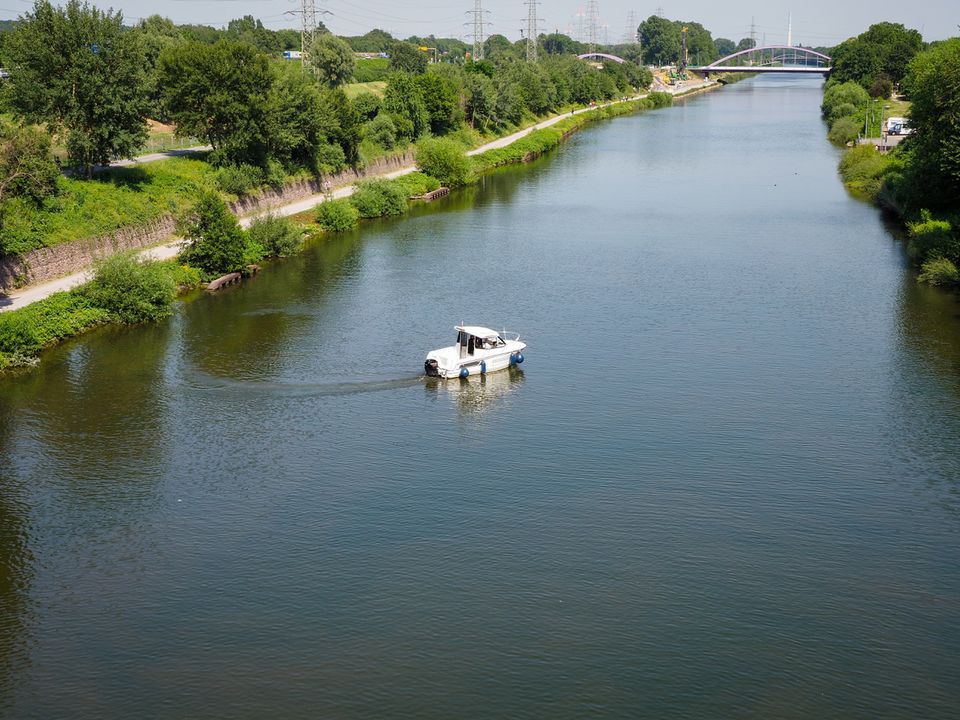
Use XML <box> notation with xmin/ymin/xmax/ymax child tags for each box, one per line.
<box><xmin>0</xmin><ymin>292</ymin><xmax>110</xmax><ymax>368</ymax></box>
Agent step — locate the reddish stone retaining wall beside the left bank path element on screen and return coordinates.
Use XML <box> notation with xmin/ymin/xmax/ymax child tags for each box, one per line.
<box><xmin>0</xmin><ymin>152</ymin><xmax>414</xmax><ymax>290</ymax></box>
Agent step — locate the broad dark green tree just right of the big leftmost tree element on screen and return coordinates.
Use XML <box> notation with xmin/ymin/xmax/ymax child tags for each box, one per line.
<box><xmin>158</xmin><ymin>40</ymin><xmax>273</xmax><ymax>166</ymax></box>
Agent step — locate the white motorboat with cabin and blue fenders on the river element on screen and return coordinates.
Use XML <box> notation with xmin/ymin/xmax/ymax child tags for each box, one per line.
<box><xmin>423</xmin><ymin>325</ymin><xmax>527</xmax><ymax>378</ymax></box>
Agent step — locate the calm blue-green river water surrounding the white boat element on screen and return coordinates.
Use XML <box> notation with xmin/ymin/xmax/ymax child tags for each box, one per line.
<box><xmin>0</xmin><ymin>78</ymin><xmax>960</xmax><ymax>718</ymax></box>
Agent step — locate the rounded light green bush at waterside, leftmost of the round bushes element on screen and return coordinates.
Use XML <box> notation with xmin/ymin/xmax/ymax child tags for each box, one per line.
<box><xmin>76</xmin><ymin>251</ymin><xmax>177</xmax><ymax>323</ymax></box>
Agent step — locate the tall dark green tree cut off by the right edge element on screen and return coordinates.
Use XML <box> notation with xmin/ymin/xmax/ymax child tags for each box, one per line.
<box><xmin>903</xmin><ymin>38</ymin><xmax>960</xmax><ymax>211</ymax></box>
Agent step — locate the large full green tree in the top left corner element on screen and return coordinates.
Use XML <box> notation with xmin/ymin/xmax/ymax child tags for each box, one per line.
<box><xmin>4</xmin><ymin>0</ymin><xmax>147</xmax><ymax>177</ymax></box>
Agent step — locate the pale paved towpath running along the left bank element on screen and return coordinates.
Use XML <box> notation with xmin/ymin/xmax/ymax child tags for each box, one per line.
<box><xmin>0</xmin><ymin>82</ymin><xmax>715</xmax><ymax>312</ymax></box>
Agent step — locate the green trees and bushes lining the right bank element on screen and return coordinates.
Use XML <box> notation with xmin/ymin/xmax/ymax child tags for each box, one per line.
<box><xmin>822</xmin><ymin>23</ymin><xmax>960</xmax><ymax>285</ymax></box>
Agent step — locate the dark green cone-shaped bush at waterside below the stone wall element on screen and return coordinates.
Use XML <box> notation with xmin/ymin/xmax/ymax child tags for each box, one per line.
<box><xmin>177</xmin><ymin>192</ymin><xmax>247</xmax><ymax>278</ymax></box>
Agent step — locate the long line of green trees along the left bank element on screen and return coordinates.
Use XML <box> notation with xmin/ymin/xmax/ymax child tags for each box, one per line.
<box><xmin>0</xmin><ymin>0</ymin><xmax>651</xmax><ymax>253</ymax></box>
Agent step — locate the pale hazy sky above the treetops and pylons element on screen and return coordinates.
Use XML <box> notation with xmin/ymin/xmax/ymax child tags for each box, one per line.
<box><xmin>0</xmin><ymin>0</ymin><xmax>960</xmax><ymax>45</ymax></box>
